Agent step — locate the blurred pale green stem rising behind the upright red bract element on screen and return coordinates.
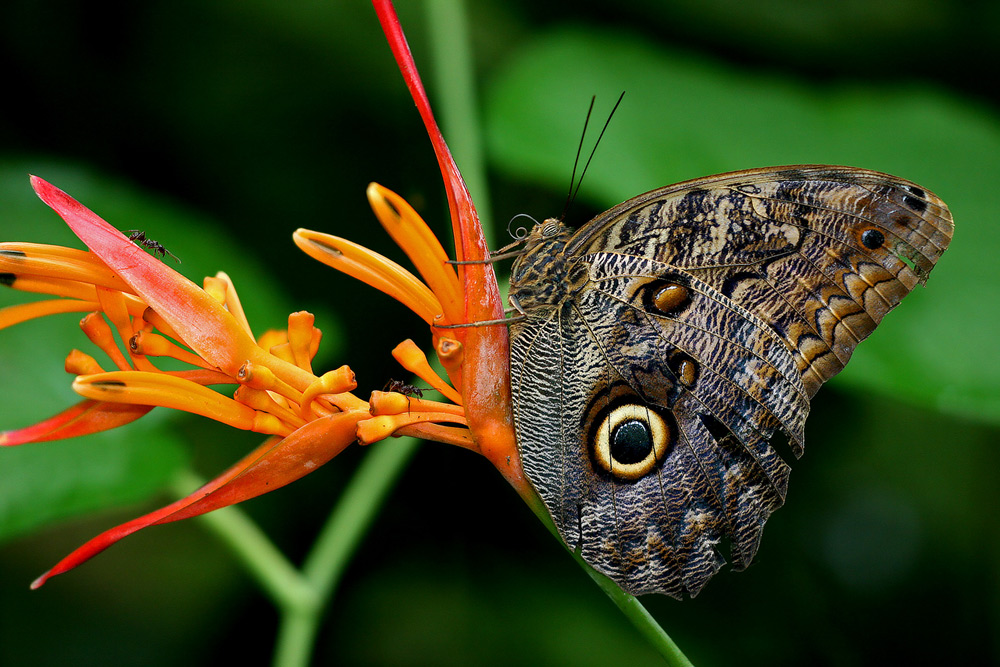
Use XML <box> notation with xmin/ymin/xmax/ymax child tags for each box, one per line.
<box><xmin>424</xmin><ymin>0</ymin><xmax>494</xmax><ymax>242</ymax></box>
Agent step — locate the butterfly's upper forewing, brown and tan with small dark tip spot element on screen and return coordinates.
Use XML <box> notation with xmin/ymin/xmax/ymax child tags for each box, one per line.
<box><xmin>566</xmin><ymin>166</ymin><xmax>954</xmax><ymax>397</ymax></box>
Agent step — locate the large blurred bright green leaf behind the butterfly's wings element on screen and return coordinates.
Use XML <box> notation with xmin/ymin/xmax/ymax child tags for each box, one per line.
<box><xmin>486</xmin><ymin>29</ymin><xmax>1000</xmax><ymax>422</ymax></box>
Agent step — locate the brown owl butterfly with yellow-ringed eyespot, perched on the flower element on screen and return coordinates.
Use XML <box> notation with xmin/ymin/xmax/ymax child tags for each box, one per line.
<box><xmin>510</xmin><ymin>166</ymin><xmax>953</xmax><ymax>597</ymax></box>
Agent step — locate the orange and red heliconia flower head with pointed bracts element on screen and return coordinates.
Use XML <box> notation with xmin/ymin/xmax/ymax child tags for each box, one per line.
<box><xmin>0</xmin><ymin>0</ymin><xmax>540</xmax><ymax>588</ymax></box>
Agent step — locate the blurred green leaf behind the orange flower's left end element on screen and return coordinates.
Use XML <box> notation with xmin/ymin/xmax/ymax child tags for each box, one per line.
<box><xmin>0</xmin><ymin>160</ymin><xmax>338</xmax><ymax>539</ymax></box>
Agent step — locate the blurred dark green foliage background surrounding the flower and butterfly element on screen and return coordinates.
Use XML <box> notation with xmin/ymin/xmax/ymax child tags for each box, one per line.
<box><xmin>0</xmin><ymin>0</ymin><xmax>1000</xmax><ymax>665</ymax></box>
